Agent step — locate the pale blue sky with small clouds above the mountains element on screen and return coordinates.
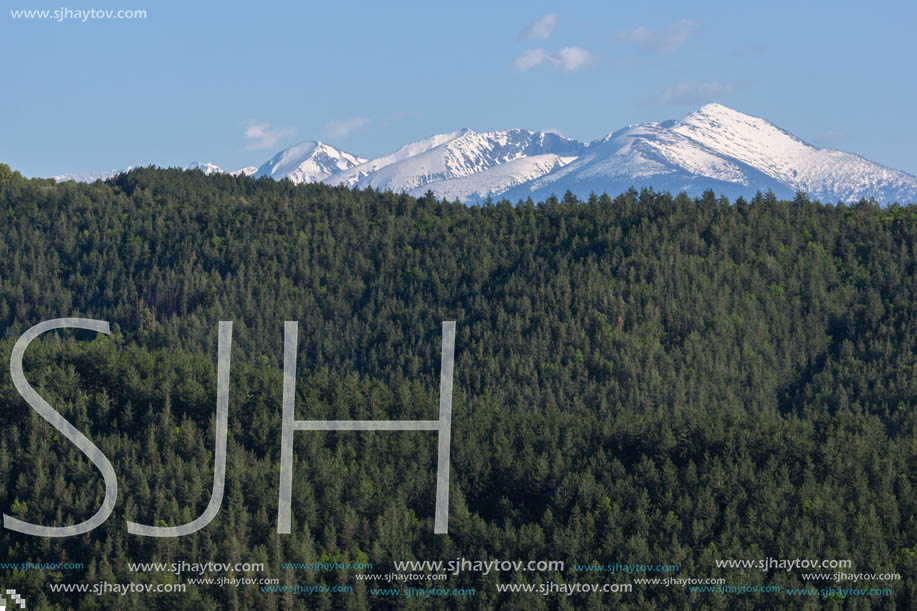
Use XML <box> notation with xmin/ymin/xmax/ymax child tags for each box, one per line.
<box><xmin>0</xmin><ymin>0</ymin><xmax>917</xmax><ymax>176</ymax></box>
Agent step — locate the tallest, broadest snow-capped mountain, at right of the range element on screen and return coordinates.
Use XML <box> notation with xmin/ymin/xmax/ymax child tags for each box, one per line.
<box><xmin>505</xmin><ymin>104</ymin><xmax>917</xmax><ymax>202</ymax></box>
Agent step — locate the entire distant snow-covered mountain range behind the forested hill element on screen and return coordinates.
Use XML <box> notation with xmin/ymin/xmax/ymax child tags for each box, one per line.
<box><xmin>54</xmin><ymin>104</ymin><xmax>917</xmax><ymax>203</ymax></box>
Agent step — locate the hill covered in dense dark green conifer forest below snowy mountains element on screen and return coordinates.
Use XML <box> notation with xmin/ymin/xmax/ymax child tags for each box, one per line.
<box><xmin>0</xmin><ymin>165</ymin><xmax>917</xmax><ymax>609</ymax></box>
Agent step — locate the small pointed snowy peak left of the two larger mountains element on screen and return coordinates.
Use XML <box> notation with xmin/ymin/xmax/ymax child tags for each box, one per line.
<box><xmin>253</xmin><ymin>140</ymin><xmax>366</xmax><ymax>183</ymax></box>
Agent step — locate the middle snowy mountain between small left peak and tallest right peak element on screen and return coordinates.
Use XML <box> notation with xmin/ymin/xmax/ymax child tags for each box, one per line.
<box><xmin>325</xmin><ymin>129</ymin><xmax>583</xmax><ymax>201</ymax></box>
